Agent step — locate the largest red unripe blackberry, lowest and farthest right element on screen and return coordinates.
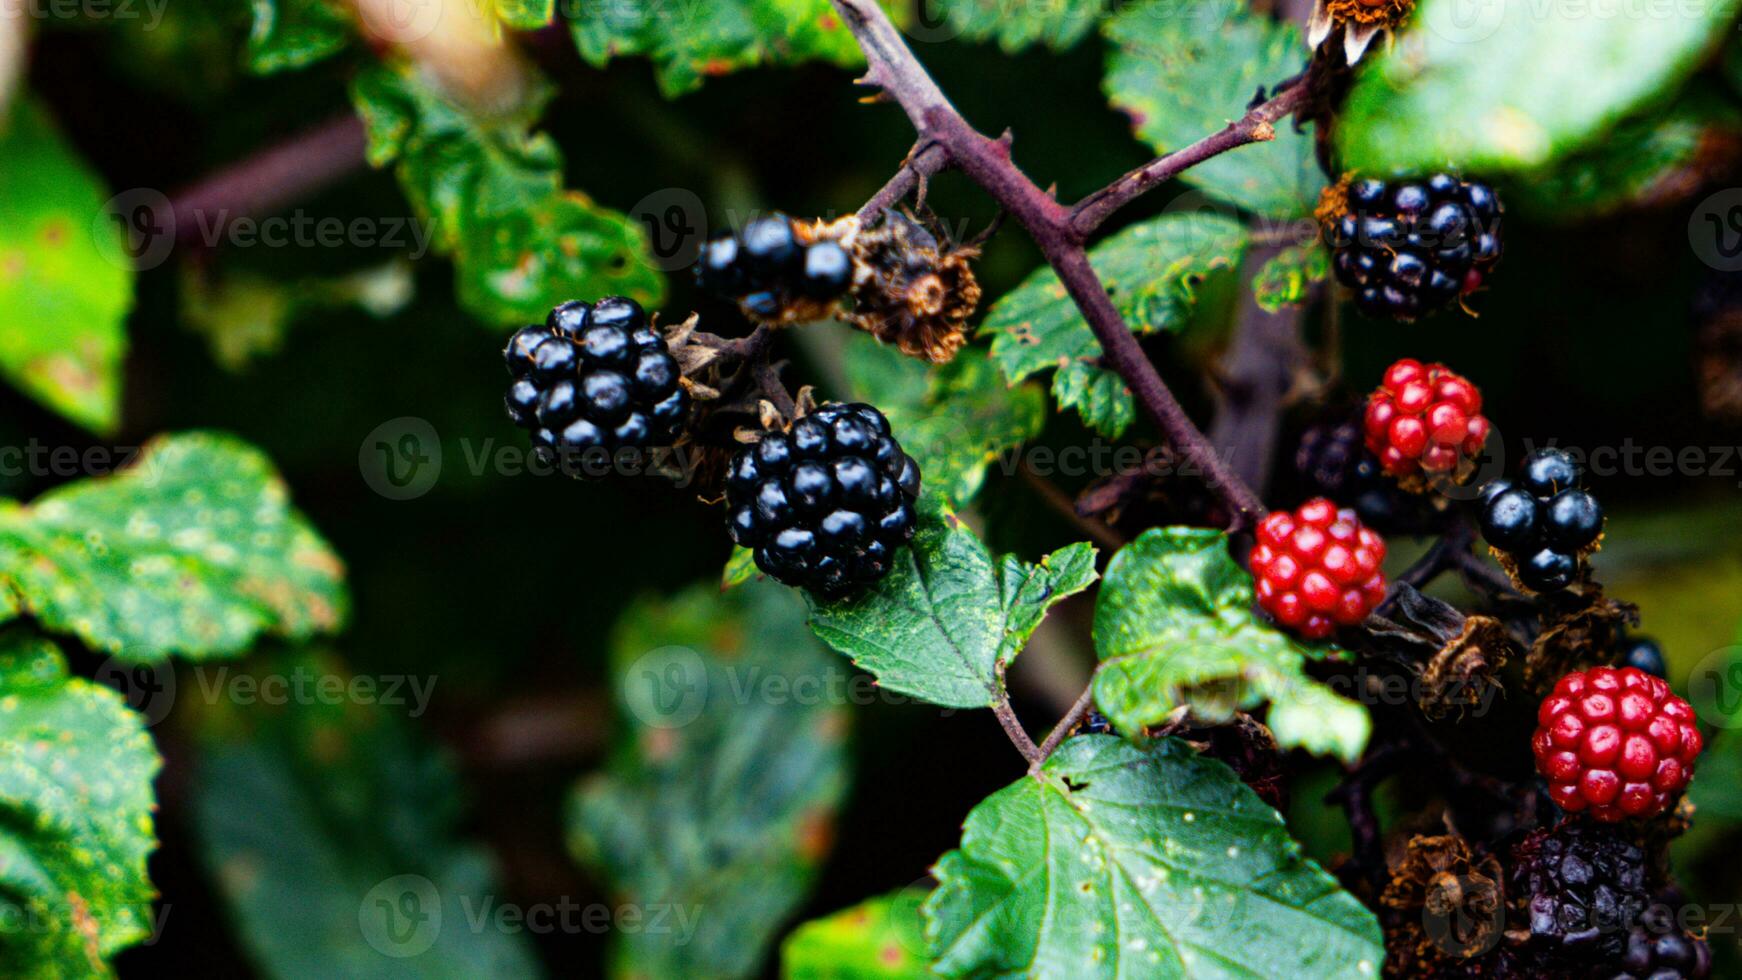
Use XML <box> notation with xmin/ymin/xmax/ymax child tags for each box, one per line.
<box><xmin>1531</xmin><ymin>667</ymin><xmax>1704</xmax><ymax>823</ymax></box>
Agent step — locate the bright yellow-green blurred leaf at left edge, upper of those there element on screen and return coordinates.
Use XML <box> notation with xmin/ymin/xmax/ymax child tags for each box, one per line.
<box><xmin>0</xmin><ymin>99</ymin><xmax>132</xmax><ymax>435</ymax></box>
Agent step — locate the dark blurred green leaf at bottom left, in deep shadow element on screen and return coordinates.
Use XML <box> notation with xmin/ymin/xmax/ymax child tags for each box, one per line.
<box><xmin>192</xmin><ymin>651</ymin><xmax>540</xmax><ymax>980</ymax></box>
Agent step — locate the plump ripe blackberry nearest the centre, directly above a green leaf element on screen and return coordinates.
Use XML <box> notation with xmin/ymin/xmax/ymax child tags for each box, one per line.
<box><xmin>726</xmin><ymin>404</ymin><xmax>920</xmax><ymax>599</ymax></box>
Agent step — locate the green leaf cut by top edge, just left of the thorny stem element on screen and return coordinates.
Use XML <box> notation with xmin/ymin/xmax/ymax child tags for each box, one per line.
<box><xmin>570</xmin><ymin>0</ymin><xmax>862</xmax><ymax>97</ymax></box>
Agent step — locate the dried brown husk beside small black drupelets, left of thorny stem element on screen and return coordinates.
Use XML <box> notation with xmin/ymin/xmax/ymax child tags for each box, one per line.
<box><xmin>843</xmin><ymin>211</ymin><xmax>981</xmax><ymax>364</ymax></box>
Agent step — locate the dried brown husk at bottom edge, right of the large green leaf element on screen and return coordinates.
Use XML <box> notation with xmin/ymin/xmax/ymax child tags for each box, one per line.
<box><xmin>1380</xmin><ymin>834</ymin><xmax>1507</xmax><ymax>977</ymax></box>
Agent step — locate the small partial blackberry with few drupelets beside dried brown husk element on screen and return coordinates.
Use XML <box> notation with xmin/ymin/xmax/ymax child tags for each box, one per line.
<box><xmin>695</xmin><ymin>214</ymin><xmax>854</xmax><ymax>320</ymax></box>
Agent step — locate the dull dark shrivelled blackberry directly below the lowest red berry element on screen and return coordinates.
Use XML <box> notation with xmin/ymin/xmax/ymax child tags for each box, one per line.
<box><xmin>1512</xmin><ymin>820</ymin><xmax>1650</xmax><ymax>964</ymax></box>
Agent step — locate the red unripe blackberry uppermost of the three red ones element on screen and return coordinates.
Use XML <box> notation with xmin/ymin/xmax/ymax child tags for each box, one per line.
<box><xmin>1362</xmin><ymin>357</ymin><xmax>1489</xmax><ymax>487</ymax></box>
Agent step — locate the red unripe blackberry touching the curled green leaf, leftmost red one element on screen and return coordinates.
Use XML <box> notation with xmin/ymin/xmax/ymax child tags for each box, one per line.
<box><xmin>1251</xmin><ymin>498</ymin><xmax>1385</xmax><ymax>639</ymax></box>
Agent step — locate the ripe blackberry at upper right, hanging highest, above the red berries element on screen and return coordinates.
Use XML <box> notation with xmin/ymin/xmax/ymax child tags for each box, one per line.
<box><xmin>1326</xmin><ymin>174</ymin><xmax>1502</xmax><ymax>320</ymax></box>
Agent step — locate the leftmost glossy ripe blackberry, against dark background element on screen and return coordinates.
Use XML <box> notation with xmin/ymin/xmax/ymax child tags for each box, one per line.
<box><xmin>503</xmin><ymin>296</ymin><xmax>690</xmax><ymax>461</ymax></box>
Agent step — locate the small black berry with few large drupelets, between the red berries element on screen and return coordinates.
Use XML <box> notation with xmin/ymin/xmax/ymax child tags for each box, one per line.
<box><xmin>1481</xmin><ymin>449</ymin><xmax>1603</xmax><ymax>592</ymax></box>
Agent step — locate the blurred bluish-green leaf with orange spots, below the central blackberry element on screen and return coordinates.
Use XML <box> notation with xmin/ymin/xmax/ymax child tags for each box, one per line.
<box><xmin>568</xmin><ymin>583</ymin><xmax>850</xmax><ymax>978</ymax></box>
